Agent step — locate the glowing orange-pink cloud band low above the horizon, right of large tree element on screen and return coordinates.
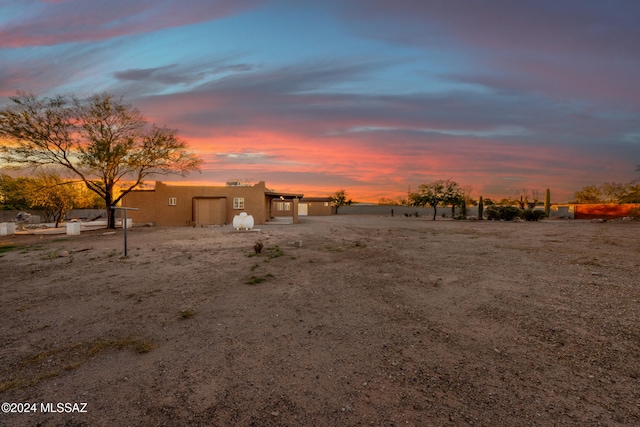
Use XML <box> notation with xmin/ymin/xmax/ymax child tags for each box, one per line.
<box><xmin>170</xmin><ymin>123</ymin><xmax>608</xmax><ymax>202</ymax></box>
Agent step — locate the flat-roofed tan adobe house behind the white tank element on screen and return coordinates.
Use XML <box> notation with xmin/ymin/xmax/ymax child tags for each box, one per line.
<box><xmin>122</xmin><ymin>181</ymin><xmax>304</xmax><ymax>227</ymax></box>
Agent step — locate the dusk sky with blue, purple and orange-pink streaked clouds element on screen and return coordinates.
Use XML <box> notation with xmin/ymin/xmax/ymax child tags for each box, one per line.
<box><xmin>0</xmin><ymin>0</ymin><xmax>640</xmax><ymax>202</ymax></box>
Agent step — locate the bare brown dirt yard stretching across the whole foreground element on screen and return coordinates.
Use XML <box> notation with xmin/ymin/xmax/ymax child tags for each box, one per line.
<box><xmin>0</xmin><ymin>216</ymin><xmax>640</xmax><ymax>426</ymax></box>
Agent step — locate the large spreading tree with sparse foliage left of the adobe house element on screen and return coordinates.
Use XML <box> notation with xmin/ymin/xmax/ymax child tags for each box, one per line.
<box><xmin>0</xmin><ymin>92</ymin><xmax>202</xmax><ymax>228</ymax></box>
